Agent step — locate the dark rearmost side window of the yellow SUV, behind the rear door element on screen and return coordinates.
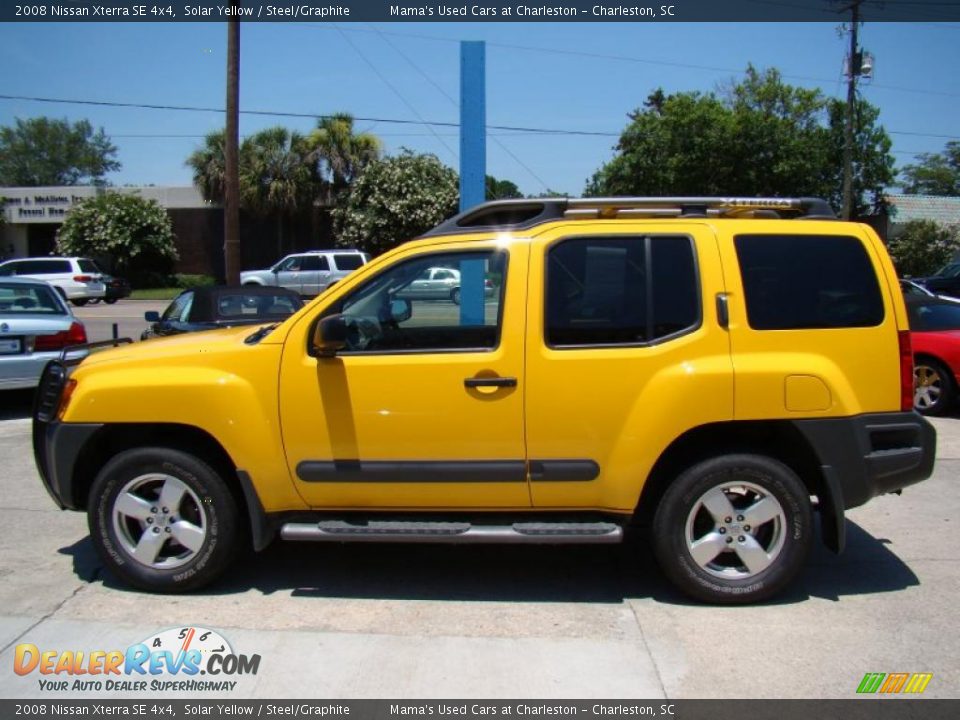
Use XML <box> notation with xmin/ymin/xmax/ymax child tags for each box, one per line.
<box><xmin>734</xmin><ymin>235</ymin><xmax>884</xmax><ymax>330</ymax></box>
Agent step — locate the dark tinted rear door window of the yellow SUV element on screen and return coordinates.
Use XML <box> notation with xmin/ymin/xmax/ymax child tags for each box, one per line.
<box><xmin>545</xmin><ymin>237</ymin><xmax>700</xmax><ymax>347</ymax></box>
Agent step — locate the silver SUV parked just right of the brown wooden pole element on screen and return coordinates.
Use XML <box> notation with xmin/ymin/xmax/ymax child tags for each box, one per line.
<box><xmin>240</xmin><ymin>250</ymin><xmax>370</xmax><ymax>297</ymax></box>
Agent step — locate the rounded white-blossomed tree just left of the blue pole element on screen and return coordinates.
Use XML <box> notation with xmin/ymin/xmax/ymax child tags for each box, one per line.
<box><xmin>333</xmin><ymin>150</ymin><xmax>459</xmax><ymax>255</ymax></box>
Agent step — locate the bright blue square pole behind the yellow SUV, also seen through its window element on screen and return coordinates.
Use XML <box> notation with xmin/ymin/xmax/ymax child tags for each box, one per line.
<box><xmin>460</xmin><ymin>40</ymin><xmax>487</xmax><ymax>325</ymax></box>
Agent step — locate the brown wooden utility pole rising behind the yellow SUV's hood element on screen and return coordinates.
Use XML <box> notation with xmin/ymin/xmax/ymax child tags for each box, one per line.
<box><xmin>223</xmin><ymin>7</ymin><xmax>240</xmax><ymax>285</ymax></box>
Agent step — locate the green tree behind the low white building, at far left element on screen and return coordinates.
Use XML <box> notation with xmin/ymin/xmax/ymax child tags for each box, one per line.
<box><xmin>0</xmin><ymin>117</ymin><xmax>120</xmax><ymax>187</ymax></box>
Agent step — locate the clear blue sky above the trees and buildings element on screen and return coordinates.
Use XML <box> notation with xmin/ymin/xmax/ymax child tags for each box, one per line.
<box><xmin>0</xmin><ymin>22</ymin><xmax>960</xmax><ymax>195</ymax></box>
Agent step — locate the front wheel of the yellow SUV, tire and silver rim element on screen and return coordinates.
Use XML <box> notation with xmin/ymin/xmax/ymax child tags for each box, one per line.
<box><xmin>87</xmin><ymin>447</ymin><xmax>242</xmax><ymax>593</ymax></box>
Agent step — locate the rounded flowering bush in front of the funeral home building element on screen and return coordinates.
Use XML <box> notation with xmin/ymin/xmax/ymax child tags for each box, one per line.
<box><xmin>57</xmin><ymin>192</ymin><xmax>177</xmax><ymax>278</ymax></box>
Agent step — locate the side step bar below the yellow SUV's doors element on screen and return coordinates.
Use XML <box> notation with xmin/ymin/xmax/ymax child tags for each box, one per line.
<box><xmin>280</xmin><ymin>520</ymin><xmax>623</xmax><ymax>545</ymax></box>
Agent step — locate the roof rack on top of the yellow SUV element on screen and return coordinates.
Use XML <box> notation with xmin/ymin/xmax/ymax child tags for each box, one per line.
<box><xmin>422</xmin><ymin>197</ymin><xmax>837</xmax><ymax>237</ymax></box>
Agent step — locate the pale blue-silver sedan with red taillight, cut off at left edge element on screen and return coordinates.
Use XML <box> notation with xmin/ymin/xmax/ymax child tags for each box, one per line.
<box><xmin>0</xmin><ymin>277</ymin><xmax>87</xmax><ymax>390</ymax></box>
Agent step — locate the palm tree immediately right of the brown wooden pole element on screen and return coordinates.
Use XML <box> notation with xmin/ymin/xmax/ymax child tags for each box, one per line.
<box><xmin>240</xmin><ymin>126</ymin><xmax>320</xmax><ymax>255</ymax></box>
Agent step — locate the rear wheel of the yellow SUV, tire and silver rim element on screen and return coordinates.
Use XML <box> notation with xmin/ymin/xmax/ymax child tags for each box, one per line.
<box><xmin>653</xmin><ymin>454</ymin><xmax>813</xmax><ymax>604</ymax></box>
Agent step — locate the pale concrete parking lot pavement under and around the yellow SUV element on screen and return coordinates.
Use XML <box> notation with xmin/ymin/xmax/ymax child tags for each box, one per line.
<box><xmin>0</xmin><ymin>301</ymin><xmax>960</xmax><ymax>701</ymax></box>
